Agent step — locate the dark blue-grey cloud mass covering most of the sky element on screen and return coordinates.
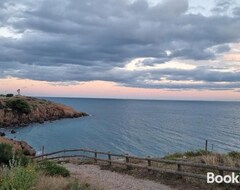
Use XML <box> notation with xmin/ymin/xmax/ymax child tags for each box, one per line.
<box><xmin>0</xmin><ymin>0</ymin><xmax>240</xmax><ymax>88</ymax></box>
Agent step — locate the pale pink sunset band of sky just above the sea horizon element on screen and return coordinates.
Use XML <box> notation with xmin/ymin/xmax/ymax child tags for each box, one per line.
<box><xmin>0</xmin><ymin>78</ymin><xmax>240</xmax><ymax>101</ymax></box>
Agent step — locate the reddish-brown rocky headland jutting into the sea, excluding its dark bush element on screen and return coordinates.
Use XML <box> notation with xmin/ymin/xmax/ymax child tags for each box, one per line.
<box><xmin>0</xmin><ymin>96</ymin><xmax>88</xmax><ymax>127</ymax></box>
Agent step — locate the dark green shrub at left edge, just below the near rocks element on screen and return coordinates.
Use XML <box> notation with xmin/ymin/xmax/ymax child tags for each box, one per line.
<box><xmin>0</xmin><ymin>143</ymin><xmax>13</xmax><ymax>164</ymax></box>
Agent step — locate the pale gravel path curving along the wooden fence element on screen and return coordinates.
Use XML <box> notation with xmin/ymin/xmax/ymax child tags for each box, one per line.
<box><xmin>64</xmin><ymin>164</ymin><xmax>172</xmax><ymax>190</ymax></box>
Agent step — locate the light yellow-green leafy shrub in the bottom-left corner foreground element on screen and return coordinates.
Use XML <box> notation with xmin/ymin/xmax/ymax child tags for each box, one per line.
<box><xmin>0</xmin><ymin>166</ymin><xmax>37</xmax><ymax>190</ymax></box>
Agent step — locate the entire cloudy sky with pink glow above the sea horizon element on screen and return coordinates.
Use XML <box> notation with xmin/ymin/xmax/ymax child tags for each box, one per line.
<box><xmin>0</xmin><ymin>0</ymin><xmax>240</xmax><ymax>101</ymax></box>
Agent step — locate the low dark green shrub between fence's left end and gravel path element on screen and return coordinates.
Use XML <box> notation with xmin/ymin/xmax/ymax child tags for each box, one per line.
<box><xmin>39</xmin><ymin>161</ymin><xmax>70</xmax><ymax>177</ymax></box>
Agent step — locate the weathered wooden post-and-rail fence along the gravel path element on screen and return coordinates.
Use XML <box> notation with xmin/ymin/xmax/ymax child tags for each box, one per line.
<box><xmin>33</xmin><ymin>149</ymin><xmax>240</xmax><ymax>180</ymax></box>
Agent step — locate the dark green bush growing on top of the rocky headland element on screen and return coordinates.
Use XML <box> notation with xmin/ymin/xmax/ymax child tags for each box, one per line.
<box><xmin>6</xmin><ymin>100</ymin><xmax>31</xmax><ymax>114</ymax></box>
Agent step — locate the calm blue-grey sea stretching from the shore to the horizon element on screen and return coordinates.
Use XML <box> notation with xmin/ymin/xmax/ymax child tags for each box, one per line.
<box><xmin>1</xmin><ymin>98</ymin><xmax>240</xmax><ymax>156</ymax></box>
